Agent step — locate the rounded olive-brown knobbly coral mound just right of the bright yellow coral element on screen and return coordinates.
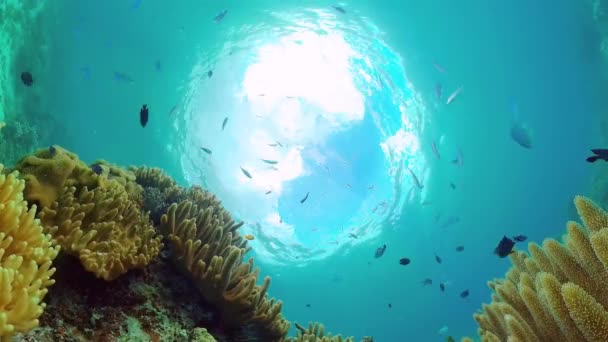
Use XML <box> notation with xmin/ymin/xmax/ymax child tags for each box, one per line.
<box><xmin>40</xmin><ymin>180</ymin><xmax>161</xmax><ymax>280</ymax></box>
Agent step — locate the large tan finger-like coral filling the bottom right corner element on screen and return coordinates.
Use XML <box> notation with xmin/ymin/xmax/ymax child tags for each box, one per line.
<box><xmin>474</xmin><ymin>196</ymin><xmax>608</xmax><ymax>342</ymax></box>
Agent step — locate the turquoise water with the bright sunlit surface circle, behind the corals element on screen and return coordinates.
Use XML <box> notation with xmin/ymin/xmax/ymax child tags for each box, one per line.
<box><xmin>2</xmin><ymin>0</ymin><xmax>605</xmax><ymax>341</ymax></box>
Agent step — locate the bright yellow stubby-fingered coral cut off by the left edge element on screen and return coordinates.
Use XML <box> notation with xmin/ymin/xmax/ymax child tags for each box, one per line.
<box><xmin>0</xmin><ymin>165</ymin><xmax>59</xmax><ymax>341</ymax></box>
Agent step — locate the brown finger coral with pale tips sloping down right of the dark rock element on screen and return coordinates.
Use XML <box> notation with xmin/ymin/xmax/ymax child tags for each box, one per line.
<box><xmin>161</xmin><ymin>201</ymin><xmax>289</xmax><ymax>341</ymax></box>
